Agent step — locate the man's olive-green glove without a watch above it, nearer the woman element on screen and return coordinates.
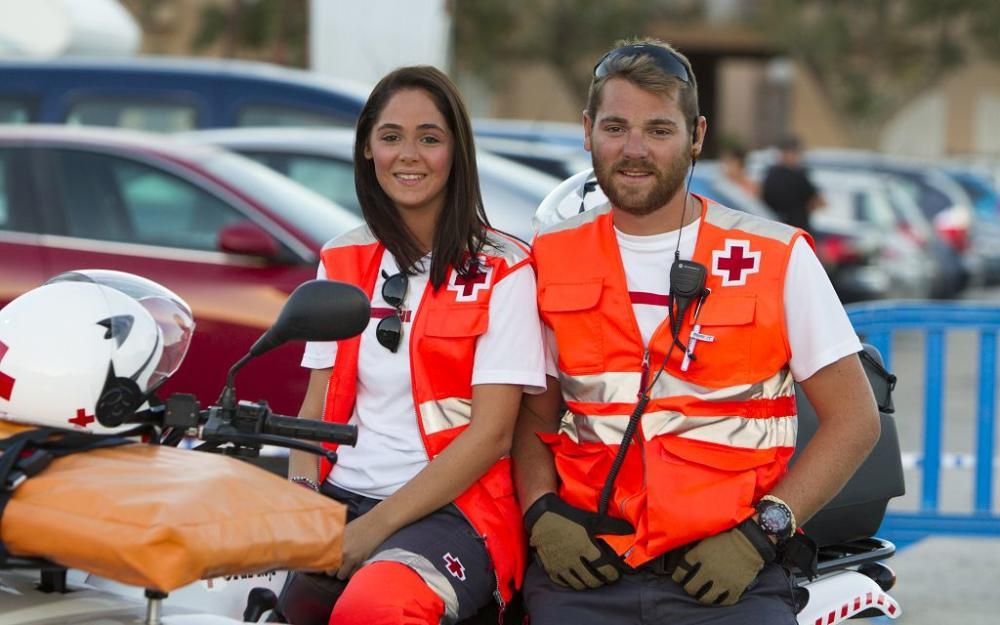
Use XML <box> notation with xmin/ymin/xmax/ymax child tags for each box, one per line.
<box><xmin>524</xmin><ymin>493</ymin><xmax>635</xmax><ymax>590</ymax></box>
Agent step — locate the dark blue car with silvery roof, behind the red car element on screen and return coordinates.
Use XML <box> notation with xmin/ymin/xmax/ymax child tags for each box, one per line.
<box><xmin>0</xmin><ymin>56</ymin><xmax>368</xmax><ymax>132</ymax></box>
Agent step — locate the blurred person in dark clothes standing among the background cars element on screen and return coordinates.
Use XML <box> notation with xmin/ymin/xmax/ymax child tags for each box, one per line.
<box><xmin>761</xmin><ymin>136</ymin><xmax>823</xmax><ymax>232</ymax></box>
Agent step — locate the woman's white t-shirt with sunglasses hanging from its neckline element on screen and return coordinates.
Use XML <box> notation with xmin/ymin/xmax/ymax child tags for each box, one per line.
<box><xmin>302</xmin><ymin>252</ymin><xmax>545</xmax><ymax>499</ymax></box>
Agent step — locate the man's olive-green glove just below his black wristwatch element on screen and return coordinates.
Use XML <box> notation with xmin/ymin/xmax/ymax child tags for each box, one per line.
<box><xmin>673</xmin><ymin>519</ymin><xmax>776</xmax><ymax>605</ymax></box>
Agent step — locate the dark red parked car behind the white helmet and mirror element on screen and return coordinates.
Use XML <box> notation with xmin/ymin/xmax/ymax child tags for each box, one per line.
<box><xmin>0</xmin><ymin>125</ymin><xmax>360</xmax><ymax>414</ymax></box>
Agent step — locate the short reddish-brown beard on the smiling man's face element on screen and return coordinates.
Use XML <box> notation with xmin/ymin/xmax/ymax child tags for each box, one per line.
<box><xmin>591</xmin><ymin>153</ymin><xmax>691</xmax><ymax>217</ymax></box>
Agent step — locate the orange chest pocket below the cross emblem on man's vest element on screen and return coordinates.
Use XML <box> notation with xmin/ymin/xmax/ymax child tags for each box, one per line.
<box><xmin>669</xmin><ymin>294</ymin><xmax>752</xmax><ymax>388</ymax></box>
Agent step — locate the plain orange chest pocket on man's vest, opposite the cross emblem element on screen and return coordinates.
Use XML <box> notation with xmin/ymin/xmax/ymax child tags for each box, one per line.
<box><xmin>538</xmin><ymin>278</ymin><xmax>604</xmax><ymax>374</ymax></box>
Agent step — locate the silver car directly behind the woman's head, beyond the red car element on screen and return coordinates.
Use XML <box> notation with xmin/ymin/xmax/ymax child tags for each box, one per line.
<box><xmin>180</xmin><ymin>128</ymin><xmax>559</xmax><ymax>241</ymax></box>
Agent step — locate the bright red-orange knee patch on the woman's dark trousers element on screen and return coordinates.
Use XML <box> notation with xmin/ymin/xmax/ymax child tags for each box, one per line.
<box><xmin>330</xmin><ymin>561</ymin><xmax>444</xmax><ymax>625</ymax></box>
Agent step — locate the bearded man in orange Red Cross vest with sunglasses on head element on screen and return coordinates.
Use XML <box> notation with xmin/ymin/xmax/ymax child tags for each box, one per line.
<box><xmin>513</xmin><ymin>40</ymin><xmax>879</xmax><ymax>625</ymax></box>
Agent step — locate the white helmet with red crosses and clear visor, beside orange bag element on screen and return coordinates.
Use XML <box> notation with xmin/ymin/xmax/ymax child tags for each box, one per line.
<box><xmin>0</xmin><ymin>270</ymin><xmax>194</xmax><ymax>434</ymax></box>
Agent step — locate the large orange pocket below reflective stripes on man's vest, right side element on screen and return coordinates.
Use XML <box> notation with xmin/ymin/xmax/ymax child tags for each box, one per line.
<box><xmin>646</xmin><ymin>436</ymin><xmax>776</xmax><ymax>549</ymax></box>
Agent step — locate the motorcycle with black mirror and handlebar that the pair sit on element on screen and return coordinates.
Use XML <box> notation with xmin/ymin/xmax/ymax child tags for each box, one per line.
<box><xmin>0</xmin><ymin>268</ymin><xmax>901</xmax><ymax>625</ymax></box>
